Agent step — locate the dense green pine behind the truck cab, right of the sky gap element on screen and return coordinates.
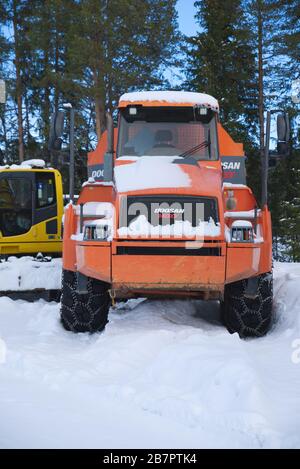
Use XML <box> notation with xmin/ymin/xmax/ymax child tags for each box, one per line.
<box><xmin>185</xmin><ymin>0</ymin><xmax>256</xmax><ymax>135</ymax></box>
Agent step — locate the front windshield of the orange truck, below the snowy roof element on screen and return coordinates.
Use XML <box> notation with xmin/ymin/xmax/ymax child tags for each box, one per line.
<box><xmin>117</xmin><ymin>106</ymin><xmax>218</xmax><ymax>160</ymax></box>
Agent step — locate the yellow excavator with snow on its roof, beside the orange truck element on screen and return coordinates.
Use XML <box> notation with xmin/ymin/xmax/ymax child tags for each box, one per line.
<box><xmin>0</xmin><ymin>160</ymin><xmax>64</xmax><ymax>257</ymax></box>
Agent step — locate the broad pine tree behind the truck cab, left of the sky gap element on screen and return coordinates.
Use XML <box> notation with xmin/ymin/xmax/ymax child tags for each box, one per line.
<box><xmin>69</xmin><ymin>0</ymin><xmax>177</xmax><ymax>139</ymax></box>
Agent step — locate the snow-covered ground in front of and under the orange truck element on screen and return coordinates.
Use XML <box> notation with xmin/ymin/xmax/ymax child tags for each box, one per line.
<box><xmin>0</xmin><ymin>264</ymin><xmax>300</xmax><ymax>448</ymax></box>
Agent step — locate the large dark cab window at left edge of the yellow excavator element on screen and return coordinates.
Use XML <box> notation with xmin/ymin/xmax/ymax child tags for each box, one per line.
<box><xmin>0</xmin><ymin>177</ymin><xmax>32</xmax><ymax>236</ymax></box>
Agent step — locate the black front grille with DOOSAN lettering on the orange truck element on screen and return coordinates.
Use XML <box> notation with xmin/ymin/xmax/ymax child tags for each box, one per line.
<box><xmin>119</xmin><ymin>195</ymin><xmax>219</xmax><ymax>228</ymax></box>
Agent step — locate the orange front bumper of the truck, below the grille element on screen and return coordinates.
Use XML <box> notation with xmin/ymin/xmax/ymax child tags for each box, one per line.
<box><xmin>76</xmin><ymin>241</ymin><xmax>226</xmax><ymax>297</ymax></box>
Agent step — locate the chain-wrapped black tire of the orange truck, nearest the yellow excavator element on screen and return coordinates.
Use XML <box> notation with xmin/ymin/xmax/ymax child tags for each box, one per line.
<box><xmin>60</xmin><ymin>270</ymin><xmax>111</xmax><ymax>332</ymax></box>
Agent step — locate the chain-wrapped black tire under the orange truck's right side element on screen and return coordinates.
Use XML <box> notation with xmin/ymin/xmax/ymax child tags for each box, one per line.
<box><xmin>221</xmin><ymin>273</ymin><xmax>273</xmax><ymax>339</ymax></box>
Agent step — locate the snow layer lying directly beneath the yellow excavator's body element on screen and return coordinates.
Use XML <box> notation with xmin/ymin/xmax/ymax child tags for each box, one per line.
<box><xmin>0</xmin><ymin>256</ymin><xmax>62</xmax><ymax>291</ymax></box>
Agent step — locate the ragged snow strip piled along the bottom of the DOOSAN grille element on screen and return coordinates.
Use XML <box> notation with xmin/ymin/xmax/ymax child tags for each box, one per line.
<box><xmin>118</xmin><ymin>215</ymin><xmax>221</xmax><ymax>239</ymax></box>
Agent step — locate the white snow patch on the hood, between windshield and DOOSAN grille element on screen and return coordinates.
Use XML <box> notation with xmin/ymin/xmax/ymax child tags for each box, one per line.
<box><xmin>115</xmin><ymin>156</ymin><xmax>191</xmax><ymax>192</ymax></box>
